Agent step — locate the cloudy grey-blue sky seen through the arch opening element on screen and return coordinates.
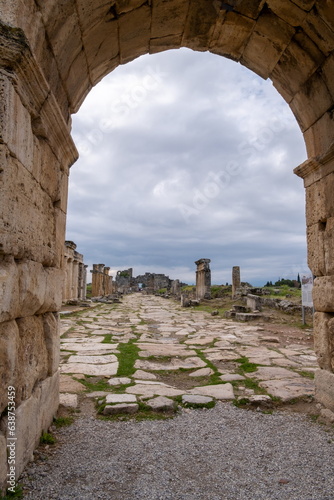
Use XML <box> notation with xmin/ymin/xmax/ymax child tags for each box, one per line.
<box><xmin>66</xmin><ymin>49</ymin><xmax>308</xmax><ymax>285</ymax></box>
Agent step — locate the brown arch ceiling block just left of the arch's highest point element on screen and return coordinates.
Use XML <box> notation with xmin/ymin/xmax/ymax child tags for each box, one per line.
<box><xmin>151</xmin><ymin>0</ymin><xmax>188</xmax><ymax>42</ymax></box>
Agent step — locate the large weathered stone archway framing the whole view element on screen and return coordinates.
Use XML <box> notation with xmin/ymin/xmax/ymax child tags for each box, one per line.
<box><xmin>0</xmin><ymin>0</ymin><xmax>334</xmax><ymax>490</ymax></box>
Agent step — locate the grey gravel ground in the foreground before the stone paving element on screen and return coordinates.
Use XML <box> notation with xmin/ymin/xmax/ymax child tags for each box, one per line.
<box><xmin>24</xmin><ymin>403</ymin><xmax>334</xmax><ymax>500</ymax></box>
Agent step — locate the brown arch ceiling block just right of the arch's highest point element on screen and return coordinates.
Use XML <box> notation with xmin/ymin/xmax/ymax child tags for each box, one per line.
<box><xmin>182</xmin><ymin>0</ymin><xmax>219</xmax><ymax>51</ymax></box>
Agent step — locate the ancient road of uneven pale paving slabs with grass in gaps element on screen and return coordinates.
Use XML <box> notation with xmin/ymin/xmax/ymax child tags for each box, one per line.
<box><xmin>60</xmin><ymin>293</ymin><xmax>317</xmax><ymax>415</ymax></box>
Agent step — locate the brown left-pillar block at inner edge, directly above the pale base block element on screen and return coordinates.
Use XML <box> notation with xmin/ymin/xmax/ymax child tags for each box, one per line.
<box><xmin>16</xmin><ymin>316</ymin><xmax>48</xmax><ymax>403</ymax></box>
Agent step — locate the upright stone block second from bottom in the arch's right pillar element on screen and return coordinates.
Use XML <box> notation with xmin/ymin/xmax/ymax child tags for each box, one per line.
<box><xmin>314</xmin><ymin>312</ymin><xmax>333</xmax><ymax>370</ymax></box>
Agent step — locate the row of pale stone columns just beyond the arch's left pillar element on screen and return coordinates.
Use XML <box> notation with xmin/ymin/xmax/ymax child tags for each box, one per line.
<box><xmin>63</xmin><ymin>241</ymin><xmax>88</xmax><ymax>302</ymax></box>
